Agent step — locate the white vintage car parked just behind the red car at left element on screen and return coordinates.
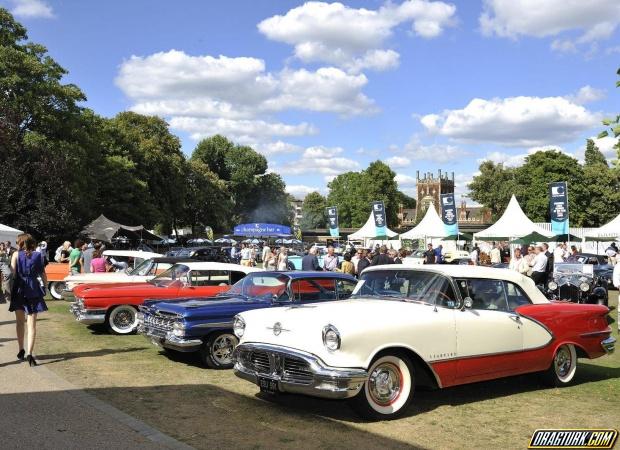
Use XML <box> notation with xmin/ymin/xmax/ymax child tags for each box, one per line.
<box><xmin>61</xmin><ymin>250</ymin><xmax>162</xmax><ymax>301</ymax></box>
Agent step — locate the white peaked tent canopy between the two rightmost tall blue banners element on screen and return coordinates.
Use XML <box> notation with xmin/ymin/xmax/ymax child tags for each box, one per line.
<box><xmin>474</xmin><ymin>195</ymin><xmax>553</xmax><ymax>241</ymax></box>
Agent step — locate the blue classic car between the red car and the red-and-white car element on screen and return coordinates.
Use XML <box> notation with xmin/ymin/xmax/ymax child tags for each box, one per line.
<box><xmin>137</xmin><ymin>271</ymin><xmax>357</xmax><ymax>369</ymax></box>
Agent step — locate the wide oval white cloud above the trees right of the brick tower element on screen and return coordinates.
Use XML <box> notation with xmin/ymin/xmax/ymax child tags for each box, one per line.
<box><xmin>420</xmin><ymin>97</ymin><xmax>598</xmax><ymax>147</ymax></box>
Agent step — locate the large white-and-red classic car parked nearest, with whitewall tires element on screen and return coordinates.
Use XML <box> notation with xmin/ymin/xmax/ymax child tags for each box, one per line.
<box><xmin>234</xmin><ymin>265</ymin><xmax>615</xmax><ymax>419</ymax></box>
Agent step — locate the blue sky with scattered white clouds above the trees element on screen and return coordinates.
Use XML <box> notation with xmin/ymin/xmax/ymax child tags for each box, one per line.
<box><xmin>0</xmin><ymin>0</ymin><xmax>620</xmax><ymax>203</ymax></box>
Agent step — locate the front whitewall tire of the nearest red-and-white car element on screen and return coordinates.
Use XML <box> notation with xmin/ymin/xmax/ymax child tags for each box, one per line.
<box><xmin>351</xmin><ymin>354</ymin><xmax>415</xmax><ymax>420</ymax></box>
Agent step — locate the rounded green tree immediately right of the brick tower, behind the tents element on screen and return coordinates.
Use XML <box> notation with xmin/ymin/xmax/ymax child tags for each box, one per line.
<box><xmin>467</xmin><ymin>161</ymin><xmax>517</xmax><ymax>219</ymax></box>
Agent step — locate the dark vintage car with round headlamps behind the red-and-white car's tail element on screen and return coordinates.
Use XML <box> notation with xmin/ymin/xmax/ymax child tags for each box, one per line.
<box><xmin>542</xmin><ymin>263</ymin><xmax>609</xmax><ymax>306</ymax></box>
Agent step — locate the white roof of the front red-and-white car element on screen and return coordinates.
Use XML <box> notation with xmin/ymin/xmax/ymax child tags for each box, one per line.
<box><xmin>363</xmin><ymin>264</ymin><xmax>549</xmax><ymax>303</ymax></box>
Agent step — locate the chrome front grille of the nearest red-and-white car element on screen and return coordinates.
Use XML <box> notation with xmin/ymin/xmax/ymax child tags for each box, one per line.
<box><xmin>241</xmin><ymin>350</ymin><xmax>314</xmax><ymax>385</ymax></box>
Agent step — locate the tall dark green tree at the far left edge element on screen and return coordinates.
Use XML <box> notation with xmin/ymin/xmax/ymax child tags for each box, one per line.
<box><xmin>0</xmin><ymin>8</ymin><xmax>98</xmax><ymax>240</ymax></box>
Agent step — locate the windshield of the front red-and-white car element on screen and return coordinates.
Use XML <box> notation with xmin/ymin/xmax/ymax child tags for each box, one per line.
<box><xmin>353</xmin><ymin>270</ymin><xmax>456</xmax><ymax>308</ymax></box>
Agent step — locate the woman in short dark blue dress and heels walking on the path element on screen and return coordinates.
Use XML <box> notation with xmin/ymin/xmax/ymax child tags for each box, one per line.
<box><xmin>9</xmin><ymin>234</ymin><xmax>47</xmax><ymax>367</ymax></box>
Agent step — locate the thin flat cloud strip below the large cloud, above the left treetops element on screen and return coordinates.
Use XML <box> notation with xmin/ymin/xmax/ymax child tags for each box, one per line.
<box><xmin>170</xmin><ymin>117</ymin><xmax>317</xmax><ymax>144</ymax></box>
